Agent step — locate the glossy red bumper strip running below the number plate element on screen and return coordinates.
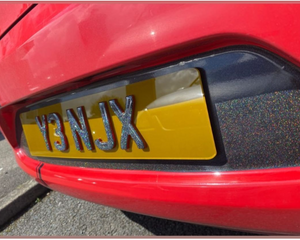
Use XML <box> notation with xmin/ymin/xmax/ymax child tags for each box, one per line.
<box><xmin>16</xmin><ymin>150</ymin><xmax>300</xmax><ymax>233</ymax></box>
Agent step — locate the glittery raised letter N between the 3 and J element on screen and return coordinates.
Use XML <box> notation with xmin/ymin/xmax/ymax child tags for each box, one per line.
<box><xmin>67</xmin><ymin>107</ymin><xmax>94</xmax><ymax>151</ymax></box>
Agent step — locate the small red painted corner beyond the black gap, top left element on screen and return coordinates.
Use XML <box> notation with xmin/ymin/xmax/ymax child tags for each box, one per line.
<box><xmin>0</xmin><ymin>3</ymin><xmax>32</xmax><ymax>36</ymax></box>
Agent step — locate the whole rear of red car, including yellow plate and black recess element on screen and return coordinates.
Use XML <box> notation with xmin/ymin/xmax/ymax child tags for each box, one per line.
<box><xmin>0</xmin><ymin>3</ymin><xmax>300</xmax><ymax>234</ymax></box>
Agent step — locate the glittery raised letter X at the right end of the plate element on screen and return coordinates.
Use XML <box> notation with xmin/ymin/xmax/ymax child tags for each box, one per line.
<box><xmin>109</xmin><ymin>96</ymin><xmax>146</xmax><ymax>149</ymax></box>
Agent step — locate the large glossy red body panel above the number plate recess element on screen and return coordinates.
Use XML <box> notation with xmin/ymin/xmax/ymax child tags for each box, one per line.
<box><xmin>0</xmin><ymin>3</ymin><xmax>300</xmax><ymax>106</ymax></box>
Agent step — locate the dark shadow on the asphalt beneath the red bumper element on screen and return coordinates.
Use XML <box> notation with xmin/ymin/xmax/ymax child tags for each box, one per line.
<box><xmin>122</xmin><ymin>211</ymin><xmax>256</xmax><ymax>236</ymax></box>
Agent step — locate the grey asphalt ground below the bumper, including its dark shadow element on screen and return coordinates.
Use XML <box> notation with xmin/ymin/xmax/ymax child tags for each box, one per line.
<box><xmin>0</xmin><ymin>191</ymin><xmax>258</xmax><ymax>237</ymax></box>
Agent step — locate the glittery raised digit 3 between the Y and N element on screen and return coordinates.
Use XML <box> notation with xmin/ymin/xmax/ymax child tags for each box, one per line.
<box><xmin>48</xmin><ymin>113</ymin><xmax>68</xmax><ymax>151</ymax></box>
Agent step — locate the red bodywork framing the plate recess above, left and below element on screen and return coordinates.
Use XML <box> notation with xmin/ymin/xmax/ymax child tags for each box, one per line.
<box><xmin>0</xmin><ymin>3</ymin><xmax>300</xmax><ymax>234</ymax></box>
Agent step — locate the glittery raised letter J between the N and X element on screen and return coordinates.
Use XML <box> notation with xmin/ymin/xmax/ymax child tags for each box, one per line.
<box><xmin>95</xmin><ymin>102</ymin><xmax>116</xmax><ymax>151</ymax></box>
